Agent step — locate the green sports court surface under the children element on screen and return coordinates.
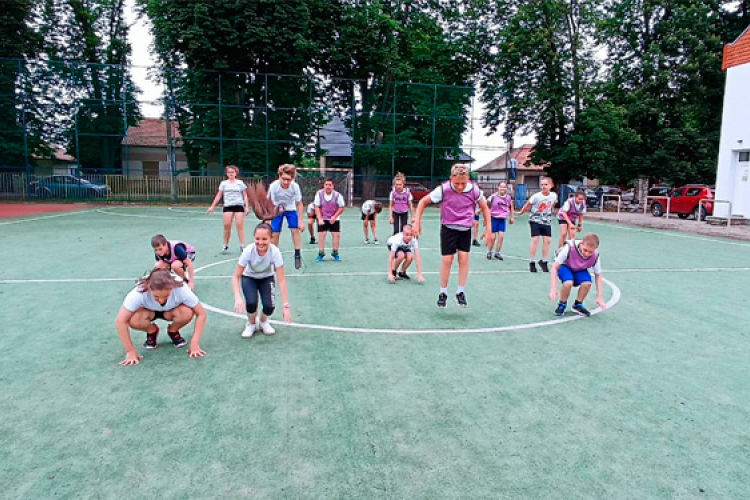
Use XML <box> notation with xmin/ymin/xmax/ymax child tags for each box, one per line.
<box><xmin>0</xmin><ymin>206</ymin><xmax>750</xmax><ymax>499</ymax></box>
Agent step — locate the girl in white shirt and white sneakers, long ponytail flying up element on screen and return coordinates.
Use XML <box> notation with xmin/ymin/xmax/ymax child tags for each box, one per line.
<box><xmin>232</xmin><ymin>223</ymin><xmax>292</xmax><ymax>339</ymax></box>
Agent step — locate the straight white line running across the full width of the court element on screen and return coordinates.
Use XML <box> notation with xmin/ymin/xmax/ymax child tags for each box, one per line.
<box><xmin>0</xmin><ymin>266</ymin><xmax>750</xmax><ymax>285</ymax></box>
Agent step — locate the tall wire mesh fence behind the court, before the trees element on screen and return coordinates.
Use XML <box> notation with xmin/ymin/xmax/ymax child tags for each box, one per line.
<box><xmin>0</xmin><ymin>59</ymin><xmax>516</xmax><ymax>191</ymax></box>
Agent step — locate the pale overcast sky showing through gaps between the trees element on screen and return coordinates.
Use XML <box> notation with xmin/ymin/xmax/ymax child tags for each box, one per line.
<box><xmin>125</xmin><ymin>0</ymin><xmax>533</xmax><ymax>168</ymax></box>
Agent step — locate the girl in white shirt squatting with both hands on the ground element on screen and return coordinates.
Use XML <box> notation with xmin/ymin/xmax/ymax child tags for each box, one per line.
<box><xmin>115</xmin><ymin>269</ymin><xmax>206</xmax><ymax>366</ymax></box>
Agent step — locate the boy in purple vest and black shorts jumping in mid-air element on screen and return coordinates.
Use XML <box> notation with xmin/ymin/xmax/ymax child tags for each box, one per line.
<box><xmin>414</xmin><ymin>163</ymin><xmax>492</xmax><ymax>309</ymax></box>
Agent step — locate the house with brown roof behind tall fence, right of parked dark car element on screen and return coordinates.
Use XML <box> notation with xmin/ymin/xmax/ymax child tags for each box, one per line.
<box><xmin>122</xmin><ymin>118</ymin><xmax>195</xmax><ymax>177</ymax></box>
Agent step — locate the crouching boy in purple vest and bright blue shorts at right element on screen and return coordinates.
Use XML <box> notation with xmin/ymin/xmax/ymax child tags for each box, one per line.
<box><xmin>549</xmin><ymin>233</ymin><xmax>607</xmax><ymax>316</ymax></box>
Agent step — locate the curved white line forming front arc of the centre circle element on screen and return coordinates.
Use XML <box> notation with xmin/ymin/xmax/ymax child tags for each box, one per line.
<box><xmin>203</xmin><ymin>280</ymin><xmax>622</xmax><ymax>335</ymax></box>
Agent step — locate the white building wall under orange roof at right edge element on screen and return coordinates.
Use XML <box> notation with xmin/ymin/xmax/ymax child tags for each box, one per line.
<box><xmin>714</xmin><ymin>63</ymin><xmax>750</xmax><ymax>218</ymax></box>
